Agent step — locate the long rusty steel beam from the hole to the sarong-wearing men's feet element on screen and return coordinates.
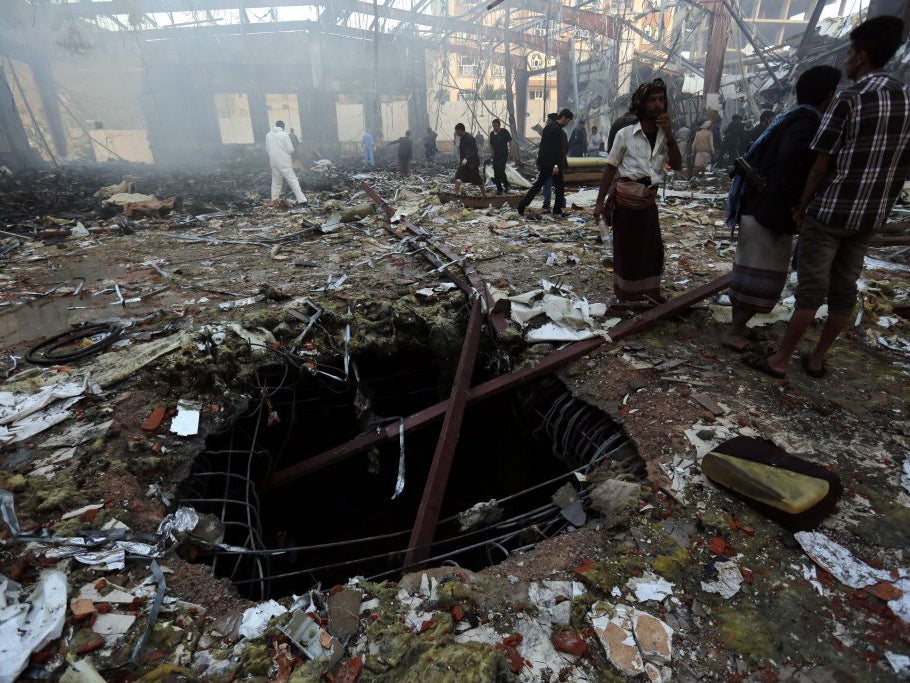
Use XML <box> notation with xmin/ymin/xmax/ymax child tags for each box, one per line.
<box><xmin>259</xmin><ymin>273</ymin><xmax>732</xmax><ymax>491</ymax></box>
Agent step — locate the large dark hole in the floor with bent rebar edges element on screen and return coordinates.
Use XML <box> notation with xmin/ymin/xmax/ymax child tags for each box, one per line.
<box><xmin>180</xmin><ymin>349</ymin><xmax>641</xmax><ymax>599</ymax></box>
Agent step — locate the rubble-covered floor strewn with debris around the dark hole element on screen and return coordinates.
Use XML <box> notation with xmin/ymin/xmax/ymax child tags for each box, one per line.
<box><xmin>0</xmin><ymin>156</ymin><xmax>910</xmax><ymax>681</ymax></box>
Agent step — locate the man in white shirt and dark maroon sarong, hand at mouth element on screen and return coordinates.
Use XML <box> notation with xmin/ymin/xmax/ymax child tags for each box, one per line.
<box><xmin>594</xmin><ymin>78</ymin><xmax>682</xmax><ymax>301</ymax></box>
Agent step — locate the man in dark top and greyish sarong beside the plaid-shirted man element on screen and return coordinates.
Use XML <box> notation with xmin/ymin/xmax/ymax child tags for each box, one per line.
<box><xmin>721</xmin><ymin>66</ymin><xmax>841</xmax><ymax>351</ymax></box>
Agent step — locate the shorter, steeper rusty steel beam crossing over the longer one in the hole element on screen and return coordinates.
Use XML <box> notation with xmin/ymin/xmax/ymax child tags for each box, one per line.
<box><xmin>404</xmin><ymin>297</ymin><xmax>483</xmax><ymax>566</ymax></box>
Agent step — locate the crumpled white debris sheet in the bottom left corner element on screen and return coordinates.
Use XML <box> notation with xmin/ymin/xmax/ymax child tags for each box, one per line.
<box><xmin>0</xmin><ymin>569</ymin><xmax>66</xmax><ymax>683</ymax></box>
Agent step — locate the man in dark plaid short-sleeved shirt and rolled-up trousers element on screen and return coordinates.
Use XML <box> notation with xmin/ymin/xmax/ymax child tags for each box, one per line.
<box><xmin>744</xmin><ymin>16</ymin><xmax>910</xmax><ymax>378</ymax></box>
